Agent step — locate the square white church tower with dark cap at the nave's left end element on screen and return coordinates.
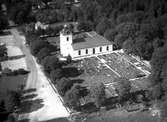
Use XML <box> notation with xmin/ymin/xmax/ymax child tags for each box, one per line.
<box><xmin>60</xmin><ymin>25</ymin><xmax>73</xmax><ymax>57</ymax></box>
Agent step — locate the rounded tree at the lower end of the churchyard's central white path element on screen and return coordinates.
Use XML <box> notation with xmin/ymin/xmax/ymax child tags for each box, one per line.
<box><xmin>114</xmin><ymin>77</ymin><xmax>131</xmax><ymax>99</ymax></box>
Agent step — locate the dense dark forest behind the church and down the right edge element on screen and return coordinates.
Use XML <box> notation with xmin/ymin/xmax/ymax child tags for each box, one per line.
<box><xmin>0</xmin><ymin>0</ymin><xmax>167</xmax><ymax>117</ymax></box>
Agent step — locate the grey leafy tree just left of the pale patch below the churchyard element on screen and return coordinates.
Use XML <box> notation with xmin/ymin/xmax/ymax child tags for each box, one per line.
<box><xmin>90</xmin><ymin>83</ymin><xmax>105</xmax><ymax>108</ymax></box>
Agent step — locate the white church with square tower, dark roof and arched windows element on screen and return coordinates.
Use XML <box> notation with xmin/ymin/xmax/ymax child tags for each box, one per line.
<box><xmin>60</xmin><ymin>25</ymin><xmax>113</xmax><ymax>59</ymax></box>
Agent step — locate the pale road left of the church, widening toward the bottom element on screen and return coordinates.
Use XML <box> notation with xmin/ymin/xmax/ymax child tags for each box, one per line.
<box><xmin>10</xmin><ymin>29</ymin><xmax>69</xmax><ymax>122</ymax></box>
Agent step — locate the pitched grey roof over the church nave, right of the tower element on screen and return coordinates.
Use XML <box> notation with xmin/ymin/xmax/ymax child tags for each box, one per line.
<box><xmin>72</xmin><ymin>31</ymin><xmax>112</xmax><ymax>50</ymax></box>
